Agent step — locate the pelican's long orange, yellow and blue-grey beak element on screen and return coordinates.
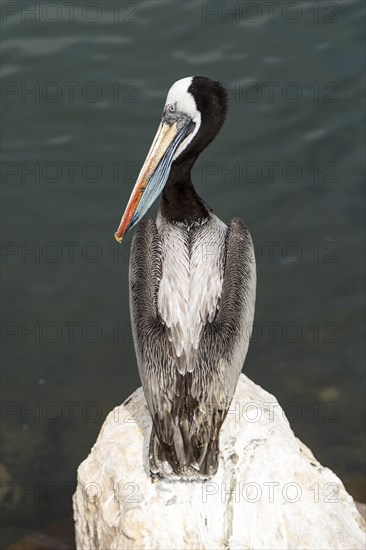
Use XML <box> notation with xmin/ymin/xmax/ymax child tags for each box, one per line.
<box><xmin>114</xmin><ymin>122</ymin><xmax>189</xmax><ymax>243</ymax></box>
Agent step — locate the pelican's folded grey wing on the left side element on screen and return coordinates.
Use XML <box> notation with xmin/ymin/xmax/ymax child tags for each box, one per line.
<box><xmin>130</xmin><ymin>222</ymin><xmax>181</xmax><ymax>445</ymax></box>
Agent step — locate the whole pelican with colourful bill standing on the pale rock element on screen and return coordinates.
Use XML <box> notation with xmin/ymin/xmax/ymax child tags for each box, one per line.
<box><xmin>115</xmin><ymin>76</ymin><xmax>256</xmax><ymax>479</ymax></box>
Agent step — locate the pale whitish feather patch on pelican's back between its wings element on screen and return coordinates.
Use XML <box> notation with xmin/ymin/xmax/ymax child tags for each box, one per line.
<box><xmin>157</xmin><ymin>211</ymin><xmax>227</xmax><ymax>374</ymax></box>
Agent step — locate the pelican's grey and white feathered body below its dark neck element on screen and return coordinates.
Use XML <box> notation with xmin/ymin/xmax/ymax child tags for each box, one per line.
<box><xmin>130</xmin><ymin>214</ymin><xmax>256</xmax><ymax>479</ymax></box>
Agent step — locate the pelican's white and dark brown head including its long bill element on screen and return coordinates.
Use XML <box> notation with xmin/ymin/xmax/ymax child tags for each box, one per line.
<box><xmin>115</xmin><ymin>76</ymin><xmax>226</xmax><ymax>242</ymax></box>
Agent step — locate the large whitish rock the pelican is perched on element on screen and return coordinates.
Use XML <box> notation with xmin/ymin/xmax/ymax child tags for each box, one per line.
<box><xmin>74</xmin><ymin>375</ymin><xmax>366</xmax><ymax>550</ymax></box>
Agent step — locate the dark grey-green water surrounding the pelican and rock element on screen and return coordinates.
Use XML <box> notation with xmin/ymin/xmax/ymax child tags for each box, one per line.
<box><xmin>1</xmin><ymin>0</ymin><xmax>365</xmax><ymax>543</ymax></box>
